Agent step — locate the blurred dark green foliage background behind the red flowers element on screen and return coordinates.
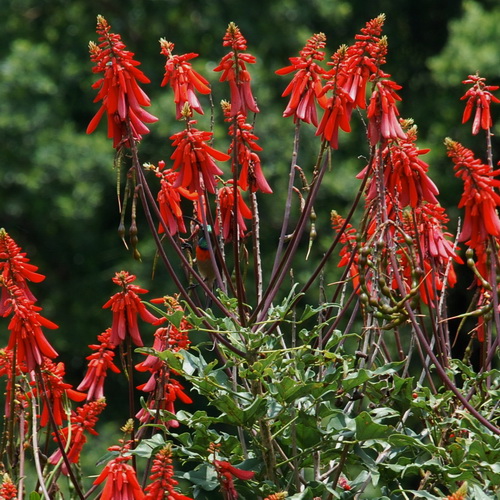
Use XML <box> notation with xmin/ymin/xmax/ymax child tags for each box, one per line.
<box><xmin>0</xmin><ymin>0</ymin><xmax>500</xmax><ymax>424</ymax></box>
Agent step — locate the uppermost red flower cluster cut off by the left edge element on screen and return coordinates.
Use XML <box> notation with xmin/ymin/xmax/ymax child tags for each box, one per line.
<box><xmin>0</xmin><ymin>228</ymin><xmax>45</xmax><ymax>316</ymax></box>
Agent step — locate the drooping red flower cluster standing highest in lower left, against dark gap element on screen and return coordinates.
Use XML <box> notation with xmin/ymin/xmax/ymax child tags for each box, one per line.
<box><xmin>102</xmin><ymin>271</ymin><xmax>158</xmax><ymax>347</ymax></box>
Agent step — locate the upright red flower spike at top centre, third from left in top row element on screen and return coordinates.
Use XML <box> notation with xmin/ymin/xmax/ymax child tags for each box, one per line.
<box><xmin>214</xmin><ymin>23</ymin><xmax>259</xmax><ymax>116</ymax></box>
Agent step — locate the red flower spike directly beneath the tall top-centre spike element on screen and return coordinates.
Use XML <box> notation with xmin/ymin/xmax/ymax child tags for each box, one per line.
<box><xmin>222</xmin><ymin>101</ymin><xmax>273</xmax><ymax>194</ymax></box>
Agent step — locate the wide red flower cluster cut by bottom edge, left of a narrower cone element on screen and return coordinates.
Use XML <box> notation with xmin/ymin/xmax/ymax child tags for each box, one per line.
<box><xmin>94</xmin><ymin>456</ymin><xmax>146</xmax><ymax>500</ymax></box>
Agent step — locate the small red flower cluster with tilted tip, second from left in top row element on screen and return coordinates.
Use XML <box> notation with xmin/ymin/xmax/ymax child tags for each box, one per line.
<box><xmin>160</xmin><ymin>38</ymin><xmax>210</xmax><ymax>120</ymax></box>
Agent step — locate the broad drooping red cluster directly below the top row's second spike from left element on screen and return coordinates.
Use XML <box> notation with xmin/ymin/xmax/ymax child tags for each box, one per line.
<box><xmin>170</xmin><ymin>120</ymin><xmax>230</xmax><ymax>196</ymax></box>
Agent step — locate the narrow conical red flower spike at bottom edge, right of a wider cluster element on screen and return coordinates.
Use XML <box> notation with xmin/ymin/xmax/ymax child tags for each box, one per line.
<box><xmin>146</xmin><ymin>445</ymin><xmax>192</xmax><ymax>500</ymax></box>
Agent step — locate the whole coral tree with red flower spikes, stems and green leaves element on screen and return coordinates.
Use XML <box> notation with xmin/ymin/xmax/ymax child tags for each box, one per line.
<box><xmin>0</xmin><ymin>11</ymin><xmax>500</xmax><ymax>500</ymax></box>
